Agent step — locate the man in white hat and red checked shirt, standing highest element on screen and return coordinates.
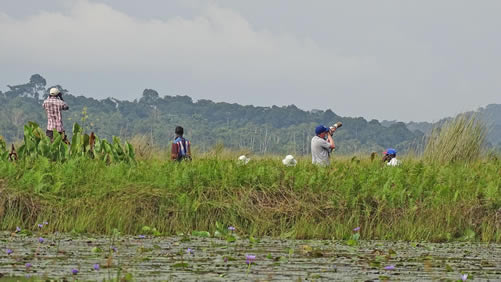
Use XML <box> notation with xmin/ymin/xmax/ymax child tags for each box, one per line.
<box><xmin>43</xmin><ymin>87</ymin><xmax>69</xmax><ymax>142</ymax></box>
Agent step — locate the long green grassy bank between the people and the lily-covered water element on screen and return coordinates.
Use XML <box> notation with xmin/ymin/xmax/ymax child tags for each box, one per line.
<box><xmin>0</xmin><ymin>157</ymin><xmax>501</xmax><ymax>242</ymax></box>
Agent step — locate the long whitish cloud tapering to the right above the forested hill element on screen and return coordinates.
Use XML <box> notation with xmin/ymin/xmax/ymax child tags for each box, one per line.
<box><xmin>0</xmin><ymin>0</ymin><xmax>367</xmax><ymax>82</ymax></box>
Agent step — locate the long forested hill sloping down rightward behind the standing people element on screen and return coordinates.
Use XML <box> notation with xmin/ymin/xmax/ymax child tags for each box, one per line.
<box><xmin>0</xmin><ymin>74</ymin><xmax>423</xmax><ymax>154</ymax></box>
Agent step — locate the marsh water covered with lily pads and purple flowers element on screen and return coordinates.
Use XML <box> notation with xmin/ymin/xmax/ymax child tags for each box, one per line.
<box><xmin>0</xmin><ymin>232</ymin><xmax>501</xmax><ymax>281</ymax></box>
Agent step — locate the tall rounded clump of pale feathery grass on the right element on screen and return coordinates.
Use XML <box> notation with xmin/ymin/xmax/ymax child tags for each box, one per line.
<box><xmin>423</xmin><ymin>114</ymin><xmax>487</xmax><ymax>164</ymax></box>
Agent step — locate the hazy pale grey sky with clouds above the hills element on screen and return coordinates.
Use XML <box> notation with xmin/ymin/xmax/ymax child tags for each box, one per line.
<box><xmin>0</xmin><ymin>0</ymin><xmax>501</xmax><ymax>122</ymax></box>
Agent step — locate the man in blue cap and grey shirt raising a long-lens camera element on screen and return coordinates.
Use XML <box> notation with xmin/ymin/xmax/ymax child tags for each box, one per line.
<box><xmin>311</xmin><ymin>125</ymin><xmax>336</xmax><ymax>166</ymax></box>
